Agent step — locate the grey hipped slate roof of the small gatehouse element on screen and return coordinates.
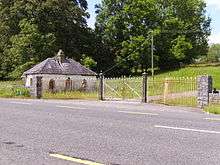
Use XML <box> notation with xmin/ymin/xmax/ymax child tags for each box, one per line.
<box><xmin>23</xmin><ymin>51</ymin><xmax>97</xmax><ymax>76</ymax></box>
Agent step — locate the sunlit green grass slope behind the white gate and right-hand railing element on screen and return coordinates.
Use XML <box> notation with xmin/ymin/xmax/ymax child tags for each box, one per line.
<box><xmin>105</xmin><ymin>64</ymin><xmax>220</xmax><ymax>98</ymax></box>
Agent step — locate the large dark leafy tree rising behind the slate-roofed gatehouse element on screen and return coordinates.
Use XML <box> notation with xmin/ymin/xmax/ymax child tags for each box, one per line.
<box><xmin>0</xmin><ymin>0</ymin><xmax>94</xmax><ymax>79</ymax></box>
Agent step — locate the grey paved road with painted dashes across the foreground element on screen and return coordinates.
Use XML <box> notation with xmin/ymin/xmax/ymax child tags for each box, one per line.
<box><xmin>0</xmin><ymin>99</ymin><xmax>220</xmax><ymax>165</ymax></box>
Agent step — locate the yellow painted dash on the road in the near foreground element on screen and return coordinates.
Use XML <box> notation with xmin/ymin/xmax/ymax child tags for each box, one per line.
<box><xmin>50</xmin><ymin>154</ymin><xmax>104</xmax><ymax>165</ymax></box>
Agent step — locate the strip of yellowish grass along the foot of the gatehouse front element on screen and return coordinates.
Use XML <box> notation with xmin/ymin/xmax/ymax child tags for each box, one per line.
<box><xmin>43</xmin><ymin>91</ymin><xmax>98</xmax><ymax>100</ymax></box>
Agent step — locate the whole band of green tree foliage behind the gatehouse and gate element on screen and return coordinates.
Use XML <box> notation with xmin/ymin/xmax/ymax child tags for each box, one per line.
<box><xmin>0</xmin><ymin>0</ymin><xmax>213</xmax><ymax>79</ymax></box>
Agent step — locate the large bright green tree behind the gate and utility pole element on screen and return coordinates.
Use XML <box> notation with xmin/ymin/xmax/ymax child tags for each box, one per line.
<box><xmin>96</xmin><ymin>0</ymin><xmax>210</xmax><ymax>74</ymax></box>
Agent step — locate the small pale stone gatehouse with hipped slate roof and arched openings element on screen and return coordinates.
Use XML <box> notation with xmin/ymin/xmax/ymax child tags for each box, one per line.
<box><xmin>22</xmin><ymin>50</ymin><xmax>97</xmax><ymax>92</ymax></box>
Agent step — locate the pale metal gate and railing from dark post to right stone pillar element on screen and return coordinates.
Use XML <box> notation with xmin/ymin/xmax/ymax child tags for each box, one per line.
<box><xmin>100</xmin><ymin>76</ymin><xmax>198</xmax><ymax>107</ymax></box>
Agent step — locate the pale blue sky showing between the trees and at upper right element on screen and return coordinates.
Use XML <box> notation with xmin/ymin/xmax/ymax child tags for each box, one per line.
<box><xmin>87</xmin><ymin>0</ymin><xmax>220</xmax><ymax>44</ymax></box>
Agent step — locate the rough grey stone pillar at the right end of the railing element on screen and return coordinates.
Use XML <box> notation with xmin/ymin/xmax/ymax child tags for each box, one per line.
<box><xmin>197</xmin><ymin>76</ymin><xmax>212</xmax><ymax>108</ymax></box>
